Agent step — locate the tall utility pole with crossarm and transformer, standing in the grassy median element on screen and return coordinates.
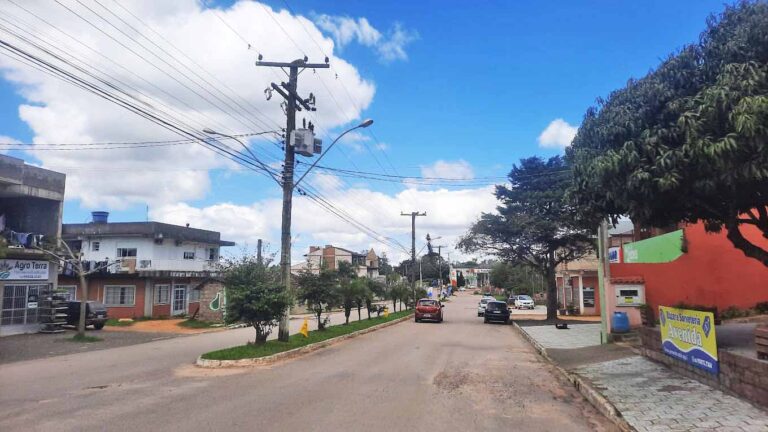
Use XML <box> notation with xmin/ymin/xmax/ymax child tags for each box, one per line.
<box><xmin>256</xmin><ymin>57</ymin><xmax>329</xmax><ymax>342</ymax></box>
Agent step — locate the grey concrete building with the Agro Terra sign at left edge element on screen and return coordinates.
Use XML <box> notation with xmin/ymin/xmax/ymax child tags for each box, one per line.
<box><xmin>0</xmin><ymin>155</ymin><xmax>65</xmax><ymax>336</ymax></box>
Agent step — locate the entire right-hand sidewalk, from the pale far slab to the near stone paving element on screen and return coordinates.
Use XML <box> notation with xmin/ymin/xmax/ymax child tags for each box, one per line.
<box><xmin>518</xmin><ymin>324</ymin><xmax>768</xmax><ymax>432</ymax></box>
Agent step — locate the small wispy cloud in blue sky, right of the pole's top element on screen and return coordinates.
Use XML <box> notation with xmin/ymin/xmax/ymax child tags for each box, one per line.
<box><xmin>315</xmin><ymin>15</ymin><xmax>419</xmax><ymax>62</ymax></box>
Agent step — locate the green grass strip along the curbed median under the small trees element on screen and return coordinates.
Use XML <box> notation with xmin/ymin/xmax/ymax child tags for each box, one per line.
<box><xmin>202</xmin><ymin>310</ymin><xmax>413</xmax><ymax>360</ymax></box>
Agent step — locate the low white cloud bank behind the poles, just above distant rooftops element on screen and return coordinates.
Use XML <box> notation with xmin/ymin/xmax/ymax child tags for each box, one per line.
<box><xmin>150</xmin><ymin>182</ymin><xmax>496</xmax><ymax>262</ymax></box>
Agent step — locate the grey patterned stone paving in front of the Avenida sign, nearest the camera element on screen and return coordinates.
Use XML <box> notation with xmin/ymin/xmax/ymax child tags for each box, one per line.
<box><xmin>574</xmin><ymin>356</ymin><xmax>768</xmax><ymax>432</ymax></box>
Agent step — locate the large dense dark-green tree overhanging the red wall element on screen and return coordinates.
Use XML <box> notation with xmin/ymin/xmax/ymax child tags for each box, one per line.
<box><xmin>567</xmin><ymin>1</ymin><xmax>768</xmax><ymax>266</ymax></box>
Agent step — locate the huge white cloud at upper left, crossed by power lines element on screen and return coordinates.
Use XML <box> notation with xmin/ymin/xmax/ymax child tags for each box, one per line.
<box><xmin>0</xmin><ymin>0</ymin><xmax>375</xmax><ymax>209</ymax></box>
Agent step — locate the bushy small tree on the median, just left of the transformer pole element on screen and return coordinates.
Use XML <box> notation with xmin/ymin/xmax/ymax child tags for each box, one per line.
<box><xmin>223</xmin><ymin>255</ymin><xmax>291</xmax><ymax>344</ymax></box>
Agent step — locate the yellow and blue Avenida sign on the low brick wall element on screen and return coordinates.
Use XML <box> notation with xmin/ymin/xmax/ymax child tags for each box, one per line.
<box><xmin>659</xmin><ymin>306</ymin><xmax>720</xmax><ymax>374</ymax></box>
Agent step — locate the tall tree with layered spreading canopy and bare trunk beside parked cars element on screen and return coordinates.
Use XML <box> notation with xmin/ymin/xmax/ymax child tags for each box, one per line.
<box><xmin>459</xmin><ymin>156</ymin><xmax>594</xmax><ymax>319</ymax></box>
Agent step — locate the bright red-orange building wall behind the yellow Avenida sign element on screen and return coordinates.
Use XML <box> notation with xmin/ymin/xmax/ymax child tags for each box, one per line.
<box><xmin>607</xmin><ymin>224</ymin><xmax>768</xmax><ymax>310</ymax></box>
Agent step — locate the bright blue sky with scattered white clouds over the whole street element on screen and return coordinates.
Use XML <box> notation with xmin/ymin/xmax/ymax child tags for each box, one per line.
<box><xmin>0</xmin><ymin>0</ymin><xmax>722</xmax><ymax>257</ymax></box>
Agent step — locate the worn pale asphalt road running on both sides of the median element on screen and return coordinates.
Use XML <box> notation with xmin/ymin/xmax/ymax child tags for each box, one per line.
<box><xmin>0</xmin><ymin>295</ymin><xmax>613</xmax><ymax>432</ymax></box>
